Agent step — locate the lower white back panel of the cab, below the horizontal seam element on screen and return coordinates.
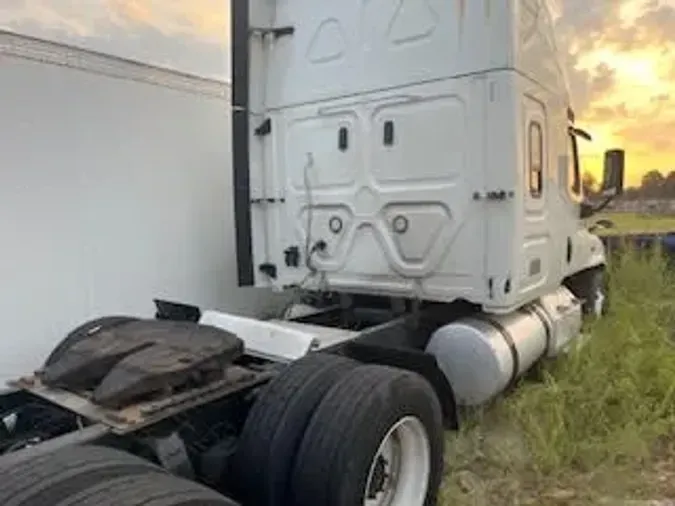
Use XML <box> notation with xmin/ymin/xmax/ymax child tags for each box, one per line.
<box><xmin>264</xmin><ymin>78</ymin><xmax>484</xmax><ymax>298</ymax></box>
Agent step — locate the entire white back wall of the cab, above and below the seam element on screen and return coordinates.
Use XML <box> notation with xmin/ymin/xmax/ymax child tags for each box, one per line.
<box><xmin>235</xmin><ymin>0</ymin><xmax>572</xmax><ymax>308</ymax></box>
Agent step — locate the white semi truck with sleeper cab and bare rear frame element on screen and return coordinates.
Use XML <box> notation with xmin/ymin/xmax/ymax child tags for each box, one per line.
<box><xmin>0</xmin><ymin>0</ymin><xmax>624</xmax><ymax>506</ymax></box>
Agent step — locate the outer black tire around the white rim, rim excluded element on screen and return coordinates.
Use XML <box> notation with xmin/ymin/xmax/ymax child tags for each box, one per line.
<box><xmin>288</xmin><ymin>366</ymin><xmax>444</xmax><ymax>506</ymax></box>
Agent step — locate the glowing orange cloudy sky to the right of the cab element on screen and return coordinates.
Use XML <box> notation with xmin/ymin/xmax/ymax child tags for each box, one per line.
<box><xmin>565</xmin><ymin>0</ymin><xmax>675</xmax><ymax>184</ymax></box>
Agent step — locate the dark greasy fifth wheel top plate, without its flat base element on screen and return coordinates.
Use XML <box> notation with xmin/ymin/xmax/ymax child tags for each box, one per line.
<box><xmin>37</xmin><ymin>320</ymin><xmax>244</xmax><ymax>410</ymax></box>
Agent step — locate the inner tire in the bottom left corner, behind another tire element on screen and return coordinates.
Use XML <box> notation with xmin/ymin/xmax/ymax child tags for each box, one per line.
<box><xmin>0</xmin><ymin>446</ymin><xmax>166</xmax><ymax>506</ymax></box>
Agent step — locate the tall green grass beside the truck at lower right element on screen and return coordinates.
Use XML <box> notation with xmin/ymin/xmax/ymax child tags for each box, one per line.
<box><xmin>441</xmin><ymin>251</ymin><xmax>675</xmax><ymax>506</ymax></box>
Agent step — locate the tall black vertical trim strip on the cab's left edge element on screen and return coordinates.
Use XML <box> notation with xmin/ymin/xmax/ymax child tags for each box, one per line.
<box><xmin>230</xmin><ymin>0</ymin><xmax>255</xmax><ymax>286</ymax></box>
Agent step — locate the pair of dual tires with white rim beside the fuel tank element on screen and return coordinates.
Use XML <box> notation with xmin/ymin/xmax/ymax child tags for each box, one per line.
<box><xmin>236</xmin><ymin>354</ymin><xmax>444</xmax><ymax>506</ymax></box>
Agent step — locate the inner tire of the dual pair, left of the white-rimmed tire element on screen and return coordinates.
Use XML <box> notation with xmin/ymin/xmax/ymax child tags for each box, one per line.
<box><xmin>235</xmin><ymin>353</ymin><xmax>358</xmax><ymax>506</ymax></box>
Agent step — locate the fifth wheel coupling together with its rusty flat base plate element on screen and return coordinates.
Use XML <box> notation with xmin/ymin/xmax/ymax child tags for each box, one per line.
<box><xmin>5</xmin><ymin>320</ymin><xmax>273</xmax><ymax>434</ymax></box>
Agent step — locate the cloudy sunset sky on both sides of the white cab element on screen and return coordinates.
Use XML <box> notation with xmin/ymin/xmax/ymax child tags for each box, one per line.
<box><xmin>0</xmin><ymin>0</ymin><xmax>675</xmax><ymax>187</ymax></box>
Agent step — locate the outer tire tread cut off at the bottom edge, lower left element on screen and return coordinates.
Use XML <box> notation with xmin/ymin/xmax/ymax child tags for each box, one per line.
<box><xmin>51</xmin><ymin>473</ymin><xmax>237</xmax><ymax>506</ymax></box>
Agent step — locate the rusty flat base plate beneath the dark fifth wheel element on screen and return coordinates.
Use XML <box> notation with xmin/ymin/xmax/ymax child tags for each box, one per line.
<box><xmin>12</xmin><ymin>366</ymin><xmax>274</xmax><ymax>435</ymax></box>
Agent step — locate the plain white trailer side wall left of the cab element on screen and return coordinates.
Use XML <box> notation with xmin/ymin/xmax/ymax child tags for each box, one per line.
<box><xmin>0</xmin><ymin>32</ymin><xmax>282</xmax><ymax>382</ymax></box>
